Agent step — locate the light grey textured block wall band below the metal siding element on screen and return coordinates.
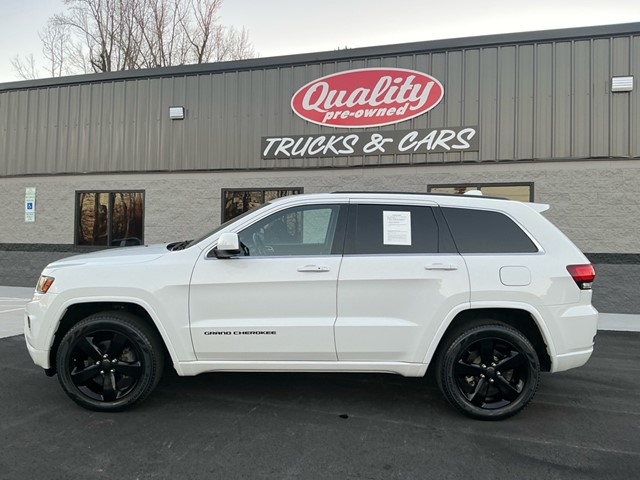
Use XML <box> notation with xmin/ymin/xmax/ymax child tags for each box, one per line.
<box><xmin>0</xmin><ymin>160</ymin><xmax>640</xmax><ymax>253</ymax></box>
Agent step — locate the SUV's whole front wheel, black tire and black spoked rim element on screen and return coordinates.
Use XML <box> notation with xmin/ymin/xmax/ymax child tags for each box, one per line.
<box><xmin>56</xmin><ymin>312</ymin><xmax>164</xmax><ymax>412</ymax></box>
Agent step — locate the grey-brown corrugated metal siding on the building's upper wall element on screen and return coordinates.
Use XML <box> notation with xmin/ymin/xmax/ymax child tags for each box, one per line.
<box><xmin>0</xmin><ymin>30</ymin><xmax>640</xmax><ymax>176</ymax></box>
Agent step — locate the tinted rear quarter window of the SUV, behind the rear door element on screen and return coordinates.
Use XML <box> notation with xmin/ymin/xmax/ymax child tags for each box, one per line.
<box><xmin>442</xmin><ymin>207</ymin><xmax>538</xmax><ymax>253</ymax></box>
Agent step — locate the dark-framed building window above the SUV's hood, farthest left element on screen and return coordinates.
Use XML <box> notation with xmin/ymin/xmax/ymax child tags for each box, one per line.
<box><xmin>76</xmin><ymin>191</ymin><xmax>144</xmax><ymax>247</ymax></box>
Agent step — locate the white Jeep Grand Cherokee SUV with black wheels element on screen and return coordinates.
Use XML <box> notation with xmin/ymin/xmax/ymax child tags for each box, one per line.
<box><xmin>25</xmin><ymin>193</ymin><xmax>598</xmax><ymax>419</ymax></box>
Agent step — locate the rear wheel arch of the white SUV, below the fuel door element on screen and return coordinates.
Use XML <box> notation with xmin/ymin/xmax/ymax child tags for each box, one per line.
<box><xmin>425</xmin><ymin>306</ymin><xmax>554</xmax><ymax>372</ymax></box>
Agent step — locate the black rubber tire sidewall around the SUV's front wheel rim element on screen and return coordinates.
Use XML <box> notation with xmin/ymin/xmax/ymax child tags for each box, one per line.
<box><xmin>56</xmin><ymin>312</ymin><xmax>163</xmax><ymax>411</ymax></box>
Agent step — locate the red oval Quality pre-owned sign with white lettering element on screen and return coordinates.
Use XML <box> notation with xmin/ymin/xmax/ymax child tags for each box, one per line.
<box><xmin>291</xmin><ymin>68</ymin><xmax>444</xmax><ymax>128</ymax></box>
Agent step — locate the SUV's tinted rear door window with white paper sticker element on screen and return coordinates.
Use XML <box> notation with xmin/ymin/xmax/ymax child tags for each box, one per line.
<box><xmin>348</xmin><ymin>204</ymin><xmax>438</xmax><ymax>254</ymax></box>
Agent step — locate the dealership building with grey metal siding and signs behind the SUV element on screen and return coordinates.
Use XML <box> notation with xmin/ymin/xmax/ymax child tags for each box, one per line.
<box><xmin>0</xmin><ymin>23</ymin><xmax>640</xmax><ymax>313</ymax></box>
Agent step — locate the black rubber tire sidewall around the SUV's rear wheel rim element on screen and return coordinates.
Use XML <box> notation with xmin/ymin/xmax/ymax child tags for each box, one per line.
<box><xmin>437</xmin><ymin>324</ymin><xmax>540</xmax><ymax>420</ymax></box>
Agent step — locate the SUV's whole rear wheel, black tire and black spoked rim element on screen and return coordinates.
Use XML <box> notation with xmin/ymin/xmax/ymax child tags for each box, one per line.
<box><xmin>436</xmin><ymin>320</ymin><xmax>540</xmax><ymax>420</ymax></box>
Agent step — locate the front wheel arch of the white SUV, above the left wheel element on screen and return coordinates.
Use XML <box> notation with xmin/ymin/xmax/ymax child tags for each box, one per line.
<box><xmin>46</xmin><ymin>300</ymin><xmax>176</xmax><ymax>376</ymax></box>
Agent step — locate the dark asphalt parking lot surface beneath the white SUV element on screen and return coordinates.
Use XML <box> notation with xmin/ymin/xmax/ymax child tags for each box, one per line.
<box><xmin>0</xmin><ymin>332</ymin><xmax>640</xmax><ymax>480</ymax></box>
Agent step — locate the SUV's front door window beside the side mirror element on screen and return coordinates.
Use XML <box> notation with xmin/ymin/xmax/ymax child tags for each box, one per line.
<box><xmin>238</xmin><ymin>205</ymin><xmax>344</xmax><ymax>256</ymax></box>
